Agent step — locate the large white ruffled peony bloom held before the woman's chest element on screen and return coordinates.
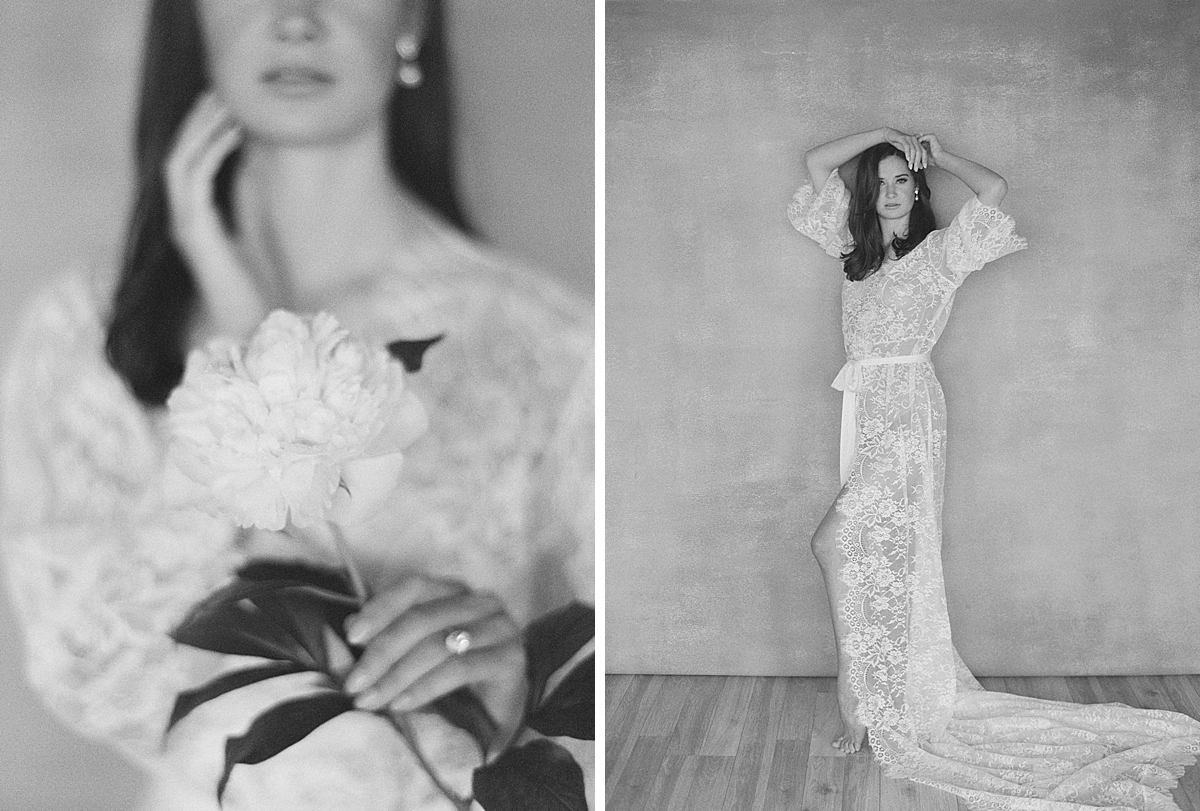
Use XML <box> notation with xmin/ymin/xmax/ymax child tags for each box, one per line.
<box><xmin>166</xmin><ymin>310</ymin><xmax>428</xmax><ymax>530</ymax></box>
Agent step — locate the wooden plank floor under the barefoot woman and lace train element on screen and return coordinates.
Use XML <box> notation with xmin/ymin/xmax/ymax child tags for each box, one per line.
<box><xmin>605</xmin><ymin>675</ymin><xmax>1200</xmax><ymax>811</ymax></box>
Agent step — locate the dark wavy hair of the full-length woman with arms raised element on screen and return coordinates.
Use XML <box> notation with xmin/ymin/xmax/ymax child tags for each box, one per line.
<box><xmin>841</xmin><ymin>143</ymin><xmax>937</xmax><ymax>282</ymax></box>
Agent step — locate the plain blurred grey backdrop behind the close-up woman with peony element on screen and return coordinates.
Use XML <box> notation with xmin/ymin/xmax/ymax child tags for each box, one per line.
<box><xmin>0</xmin><ymin>0</ymin><xmax>595</xmax><ymax>811</ymax></box>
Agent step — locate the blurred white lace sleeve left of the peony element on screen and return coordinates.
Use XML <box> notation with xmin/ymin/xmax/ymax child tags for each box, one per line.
<box><xmin>0</xmin><ymin>277</ymin><xmax>241</xmax><ymax>761</ymax></box>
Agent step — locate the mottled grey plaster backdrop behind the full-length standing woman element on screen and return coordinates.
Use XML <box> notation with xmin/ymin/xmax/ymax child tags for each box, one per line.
<box><xmin>605</xmin><ymin>0</ymin><xmax>1200</xmax><ymax>675</ymax></box>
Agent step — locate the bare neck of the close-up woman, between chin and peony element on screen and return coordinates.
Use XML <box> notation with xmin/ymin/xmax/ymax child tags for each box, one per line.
<box><xmin>234</xmin><ymin>128</ymin><xmax>428</xmax><ymax>310</ymax></box>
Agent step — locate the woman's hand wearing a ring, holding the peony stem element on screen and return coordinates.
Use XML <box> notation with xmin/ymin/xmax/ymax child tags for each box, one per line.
<box><xmin>346</xmin><ymin>576</ymin><xmax>528</xmax><ymax>743</ymax></box>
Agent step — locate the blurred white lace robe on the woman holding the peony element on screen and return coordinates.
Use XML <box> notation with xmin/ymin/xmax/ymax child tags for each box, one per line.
<box><xmin>2</xmin><ymin>218</ymin><xmax>594</xmax><ymax>811</ymax></box>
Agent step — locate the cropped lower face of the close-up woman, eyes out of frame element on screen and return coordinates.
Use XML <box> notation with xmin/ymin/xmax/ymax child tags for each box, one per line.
<box><xmin>197</xmin><ymin>0</ymin><xmax>405</xmax><ymax>145</ymax></box>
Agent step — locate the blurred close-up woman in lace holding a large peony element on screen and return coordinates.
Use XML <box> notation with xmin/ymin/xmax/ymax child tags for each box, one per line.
<box><xmin>4</xmin><ymin>0</ymin><xmax>593</xmax><ymax>810</ymax></box>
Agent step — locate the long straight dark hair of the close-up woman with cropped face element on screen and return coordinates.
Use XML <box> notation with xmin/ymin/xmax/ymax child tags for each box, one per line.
<box><xmin>106</xmin><ymin>0</ymin><xmax>470</xmax><ymax>406</ymax></box>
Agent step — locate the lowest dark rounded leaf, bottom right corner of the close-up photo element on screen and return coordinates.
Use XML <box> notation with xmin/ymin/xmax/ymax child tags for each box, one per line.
<box><xmin>472</xmin><ymin>739</ymin><xmax>588</xmax><ymax>811</ymax></box>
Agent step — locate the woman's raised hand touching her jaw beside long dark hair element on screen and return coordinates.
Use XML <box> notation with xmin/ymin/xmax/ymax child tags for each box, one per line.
<box><xmin>164</xmin><ymin>92</ymin><xmax>265</xmax><ymax>335</ymax></box>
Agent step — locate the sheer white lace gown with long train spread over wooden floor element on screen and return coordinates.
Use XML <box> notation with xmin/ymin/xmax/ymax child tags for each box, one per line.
<box><xmin>788</xmin><ymin>170</ymin><xmax>1200</xmax><ymax>811</ymax></box>
